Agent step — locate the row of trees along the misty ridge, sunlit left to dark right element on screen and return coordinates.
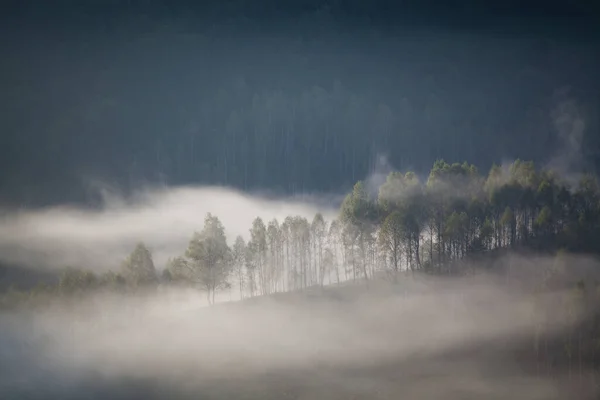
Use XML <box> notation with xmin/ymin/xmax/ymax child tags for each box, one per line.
<box><xmin>3</xmin><ymin>160</ymin><xmax>600</xmax><ymax>305</ymax></box>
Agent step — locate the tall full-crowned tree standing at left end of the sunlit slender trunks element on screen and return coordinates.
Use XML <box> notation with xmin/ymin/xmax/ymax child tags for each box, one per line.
<box><xmin>184</xmin><ymin>213</ymin><xmax>233</xmax><ymax>305</ymax></box>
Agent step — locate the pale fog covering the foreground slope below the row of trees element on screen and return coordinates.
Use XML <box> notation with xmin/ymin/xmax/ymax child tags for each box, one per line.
<box><xmin>0</xmin><ymin>277</ymin><xmax>593</xmax><ymax>400</ymax></box>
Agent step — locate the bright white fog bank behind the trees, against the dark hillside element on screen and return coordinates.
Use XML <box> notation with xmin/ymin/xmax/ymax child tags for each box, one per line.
<box><xmin>0</xmin><ymin>186</ymin><xmax>335</xmax><ymax>269</ymax></box>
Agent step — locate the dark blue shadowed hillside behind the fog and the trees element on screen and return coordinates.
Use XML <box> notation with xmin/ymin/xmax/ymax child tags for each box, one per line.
<box><xmin>0</xmin><ymin>0</ymin><xmax>600</xmax><ymax>206</ymax></box>
